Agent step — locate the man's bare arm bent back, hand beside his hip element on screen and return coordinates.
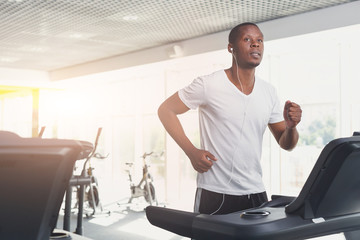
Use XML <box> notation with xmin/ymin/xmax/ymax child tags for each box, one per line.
<box><xmin>158</xmin><ymin>93</ymin><xmax>216</xmax><ymax>173</ymax></box>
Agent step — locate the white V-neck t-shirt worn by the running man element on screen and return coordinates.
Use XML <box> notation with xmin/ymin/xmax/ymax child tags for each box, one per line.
<box><xmin>178</xmin><ymin>70</ymin><xmax>284</xmax><ymax>195</ymax></box>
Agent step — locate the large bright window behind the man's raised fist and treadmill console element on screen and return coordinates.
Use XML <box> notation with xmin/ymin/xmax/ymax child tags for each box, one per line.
<box><xmin>259</xmin><ymin>23</ymin><xmax>360</xmax><ymax>195</ymax></box>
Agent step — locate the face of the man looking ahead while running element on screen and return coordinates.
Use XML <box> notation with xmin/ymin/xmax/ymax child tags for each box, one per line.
<box><xmin>234</xmin><ymin>25</ymin><xmax>264</xmax><ymax>68</ymax></box>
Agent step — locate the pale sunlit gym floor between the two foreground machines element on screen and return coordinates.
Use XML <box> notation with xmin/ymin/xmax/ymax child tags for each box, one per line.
<box><xmin>57</xmin><ymin>199</ymin><xmax>189</xmax><ymax>240</ymax></box>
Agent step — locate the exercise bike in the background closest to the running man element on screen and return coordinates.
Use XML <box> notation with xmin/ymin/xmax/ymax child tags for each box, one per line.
<box><xmin>125</xmin><ymin>152</ymin><xmax>158</xmax><ymax>205</ymax></box>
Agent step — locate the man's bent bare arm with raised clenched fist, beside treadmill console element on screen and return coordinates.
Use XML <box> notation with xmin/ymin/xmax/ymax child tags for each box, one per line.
<box><xmin>269</xmin><ymin>101</ymin><xmax>302</xmax><ymax>150</ymax></box>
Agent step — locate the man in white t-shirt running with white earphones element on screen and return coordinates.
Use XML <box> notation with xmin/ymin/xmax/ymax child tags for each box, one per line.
<box><xmin>158</xmin><ymin>23</ymin><xmax>302</xmax><ymax>214</ymax></box>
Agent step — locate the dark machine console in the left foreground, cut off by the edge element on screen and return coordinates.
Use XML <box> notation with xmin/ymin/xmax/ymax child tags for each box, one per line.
<box><xmin>0</xmin><ymin>131</ymin><xmax>92</xmax><ymax>240</ymax></box>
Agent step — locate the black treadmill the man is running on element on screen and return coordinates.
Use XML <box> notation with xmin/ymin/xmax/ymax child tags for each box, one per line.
<box><xmin>146</xmin><ymin>133</ymin><xmax>360</xmax><ymax>240</ymax></box>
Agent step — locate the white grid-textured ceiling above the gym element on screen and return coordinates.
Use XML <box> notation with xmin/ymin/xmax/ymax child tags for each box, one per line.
<box><xmin>0</xmin><ymin>0</ymin><xmax>352</xmax><ymax>71</ymax></box>
